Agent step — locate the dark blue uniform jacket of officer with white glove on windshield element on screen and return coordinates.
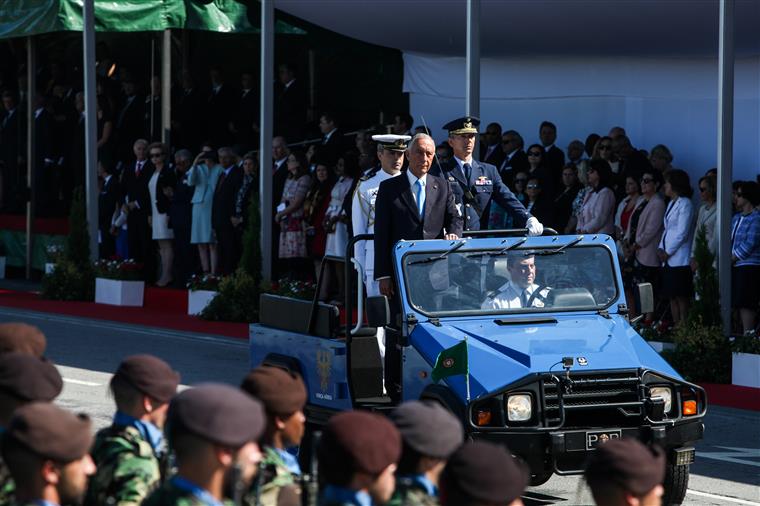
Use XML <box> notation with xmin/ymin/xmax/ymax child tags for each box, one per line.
<box><xmin>435</xmin><ymin>159</ymin><xmax>530</xmax><ymax>230</ymax></box>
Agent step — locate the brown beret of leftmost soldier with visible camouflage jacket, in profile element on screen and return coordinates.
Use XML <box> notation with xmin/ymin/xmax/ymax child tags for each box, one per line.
<box><xmin>114</xmin><ymin>355</ymin><xmax>179</xmax><ymax>403</ymax></box>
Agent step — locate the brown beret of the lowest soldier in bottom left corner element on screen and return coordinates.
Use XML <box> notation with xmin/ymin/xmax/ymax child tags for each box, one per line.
<box><xmin>6</xmin><ymin>402</ymin><xmax>93</xmax><ymax>462</ymax></box>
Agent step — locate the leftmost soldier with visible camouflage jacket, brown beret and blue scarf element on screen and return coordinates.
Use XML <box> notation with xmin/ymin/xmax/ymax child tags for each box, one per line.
<box><xmin>85</xmin><ymin>355</ymin><xmax>179</xmax><ymax>506</ymax></box>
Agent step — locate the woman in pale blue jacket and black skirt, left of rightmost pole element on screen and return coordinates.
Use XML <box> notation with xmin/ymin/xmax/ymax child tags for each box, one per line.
<box><xmin>657</xmin><ymin>169</ymin><xmax>694</xmax><ymax>324</ymax></box>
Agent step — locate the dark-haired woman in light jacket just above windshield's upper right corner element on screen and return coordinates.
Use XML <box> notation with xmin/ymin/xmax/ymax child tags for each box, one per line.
<box><xmin>578</xmin><ymin>160</ymin><xmax>615</xmax><ymax>235</ymax></box>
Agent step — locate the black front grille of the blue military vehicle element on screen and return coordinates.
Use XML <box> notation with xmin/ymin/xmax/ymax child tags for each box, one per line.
<box><xmin>541</xmin><ymin>373</ymin><xmax>643</xmax><ymax>428</ymax></box>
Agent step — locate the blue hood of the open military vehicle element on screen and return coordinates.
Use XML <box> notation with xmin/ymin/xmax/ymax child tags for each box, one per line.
<box><xmin>410</xmin><ymin>314</ymin><xmax>680</xmax><ymax>398</ymax></box>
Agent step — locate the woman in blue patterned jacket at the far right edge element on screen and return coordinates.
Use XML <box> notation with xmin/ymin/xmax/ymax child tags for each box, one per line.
<box><xmin>732</xmin><ymin>180</ymin><xmax>760</xmax><ymax>335</ymax></box>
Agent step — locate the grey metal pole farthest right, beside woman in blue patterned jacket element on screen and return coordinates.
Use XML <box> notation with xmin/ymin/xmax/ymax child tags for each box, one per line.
<box><xmin>717</xmin><ymin>0</ymin><xmax>734</xmax><ymax>335</ymax></box>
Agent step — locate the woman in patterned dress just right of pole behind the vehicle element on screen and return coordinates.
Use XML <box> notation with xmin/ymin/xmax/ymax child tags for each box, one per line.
<box><xmin>274</xmin><ymin>151</ymin><xmax>311</xmax><ymax>280</ymax></box>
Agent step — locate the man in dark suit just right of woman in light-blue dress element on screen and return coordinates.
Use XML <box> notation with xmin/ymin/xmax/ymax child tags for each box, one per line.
<box><xmin>211</xmin><ymin>147</ymin><xmax>243</xmax><ymax>276</ymax></box>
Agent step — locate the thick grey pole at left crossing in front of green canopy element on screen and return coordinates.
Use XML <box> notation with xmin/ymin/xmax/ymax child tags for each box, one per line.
<box><xmin>82</xmin><ymin>0</ymin><xmax>98</xmax><ymax>261</ymax></box>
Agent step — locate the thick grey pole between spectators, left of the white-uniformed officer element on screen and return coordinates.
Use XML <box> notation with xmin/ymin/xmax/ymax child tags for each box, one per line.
<box><xmin>259</xmin><ymin>0</ymin><xmax>274</xmax><ymax>280</ymax></box>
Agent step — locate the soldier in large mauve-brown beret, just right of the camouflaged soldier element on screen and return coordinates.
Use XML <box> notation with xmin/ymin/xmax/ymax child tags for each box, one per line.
<box><xmin>143</xmin><ymin>383</ymin><xmax>265</xmax><ymax>506</ymax></box>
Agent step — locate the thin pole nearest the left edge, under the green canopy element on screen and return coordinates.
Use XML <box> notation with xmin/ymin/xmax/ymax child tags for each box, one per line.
<box><xmin>24</xmin><ymin>36</ymin><xmax>37</xmax><ymax>279</ymax></box>
